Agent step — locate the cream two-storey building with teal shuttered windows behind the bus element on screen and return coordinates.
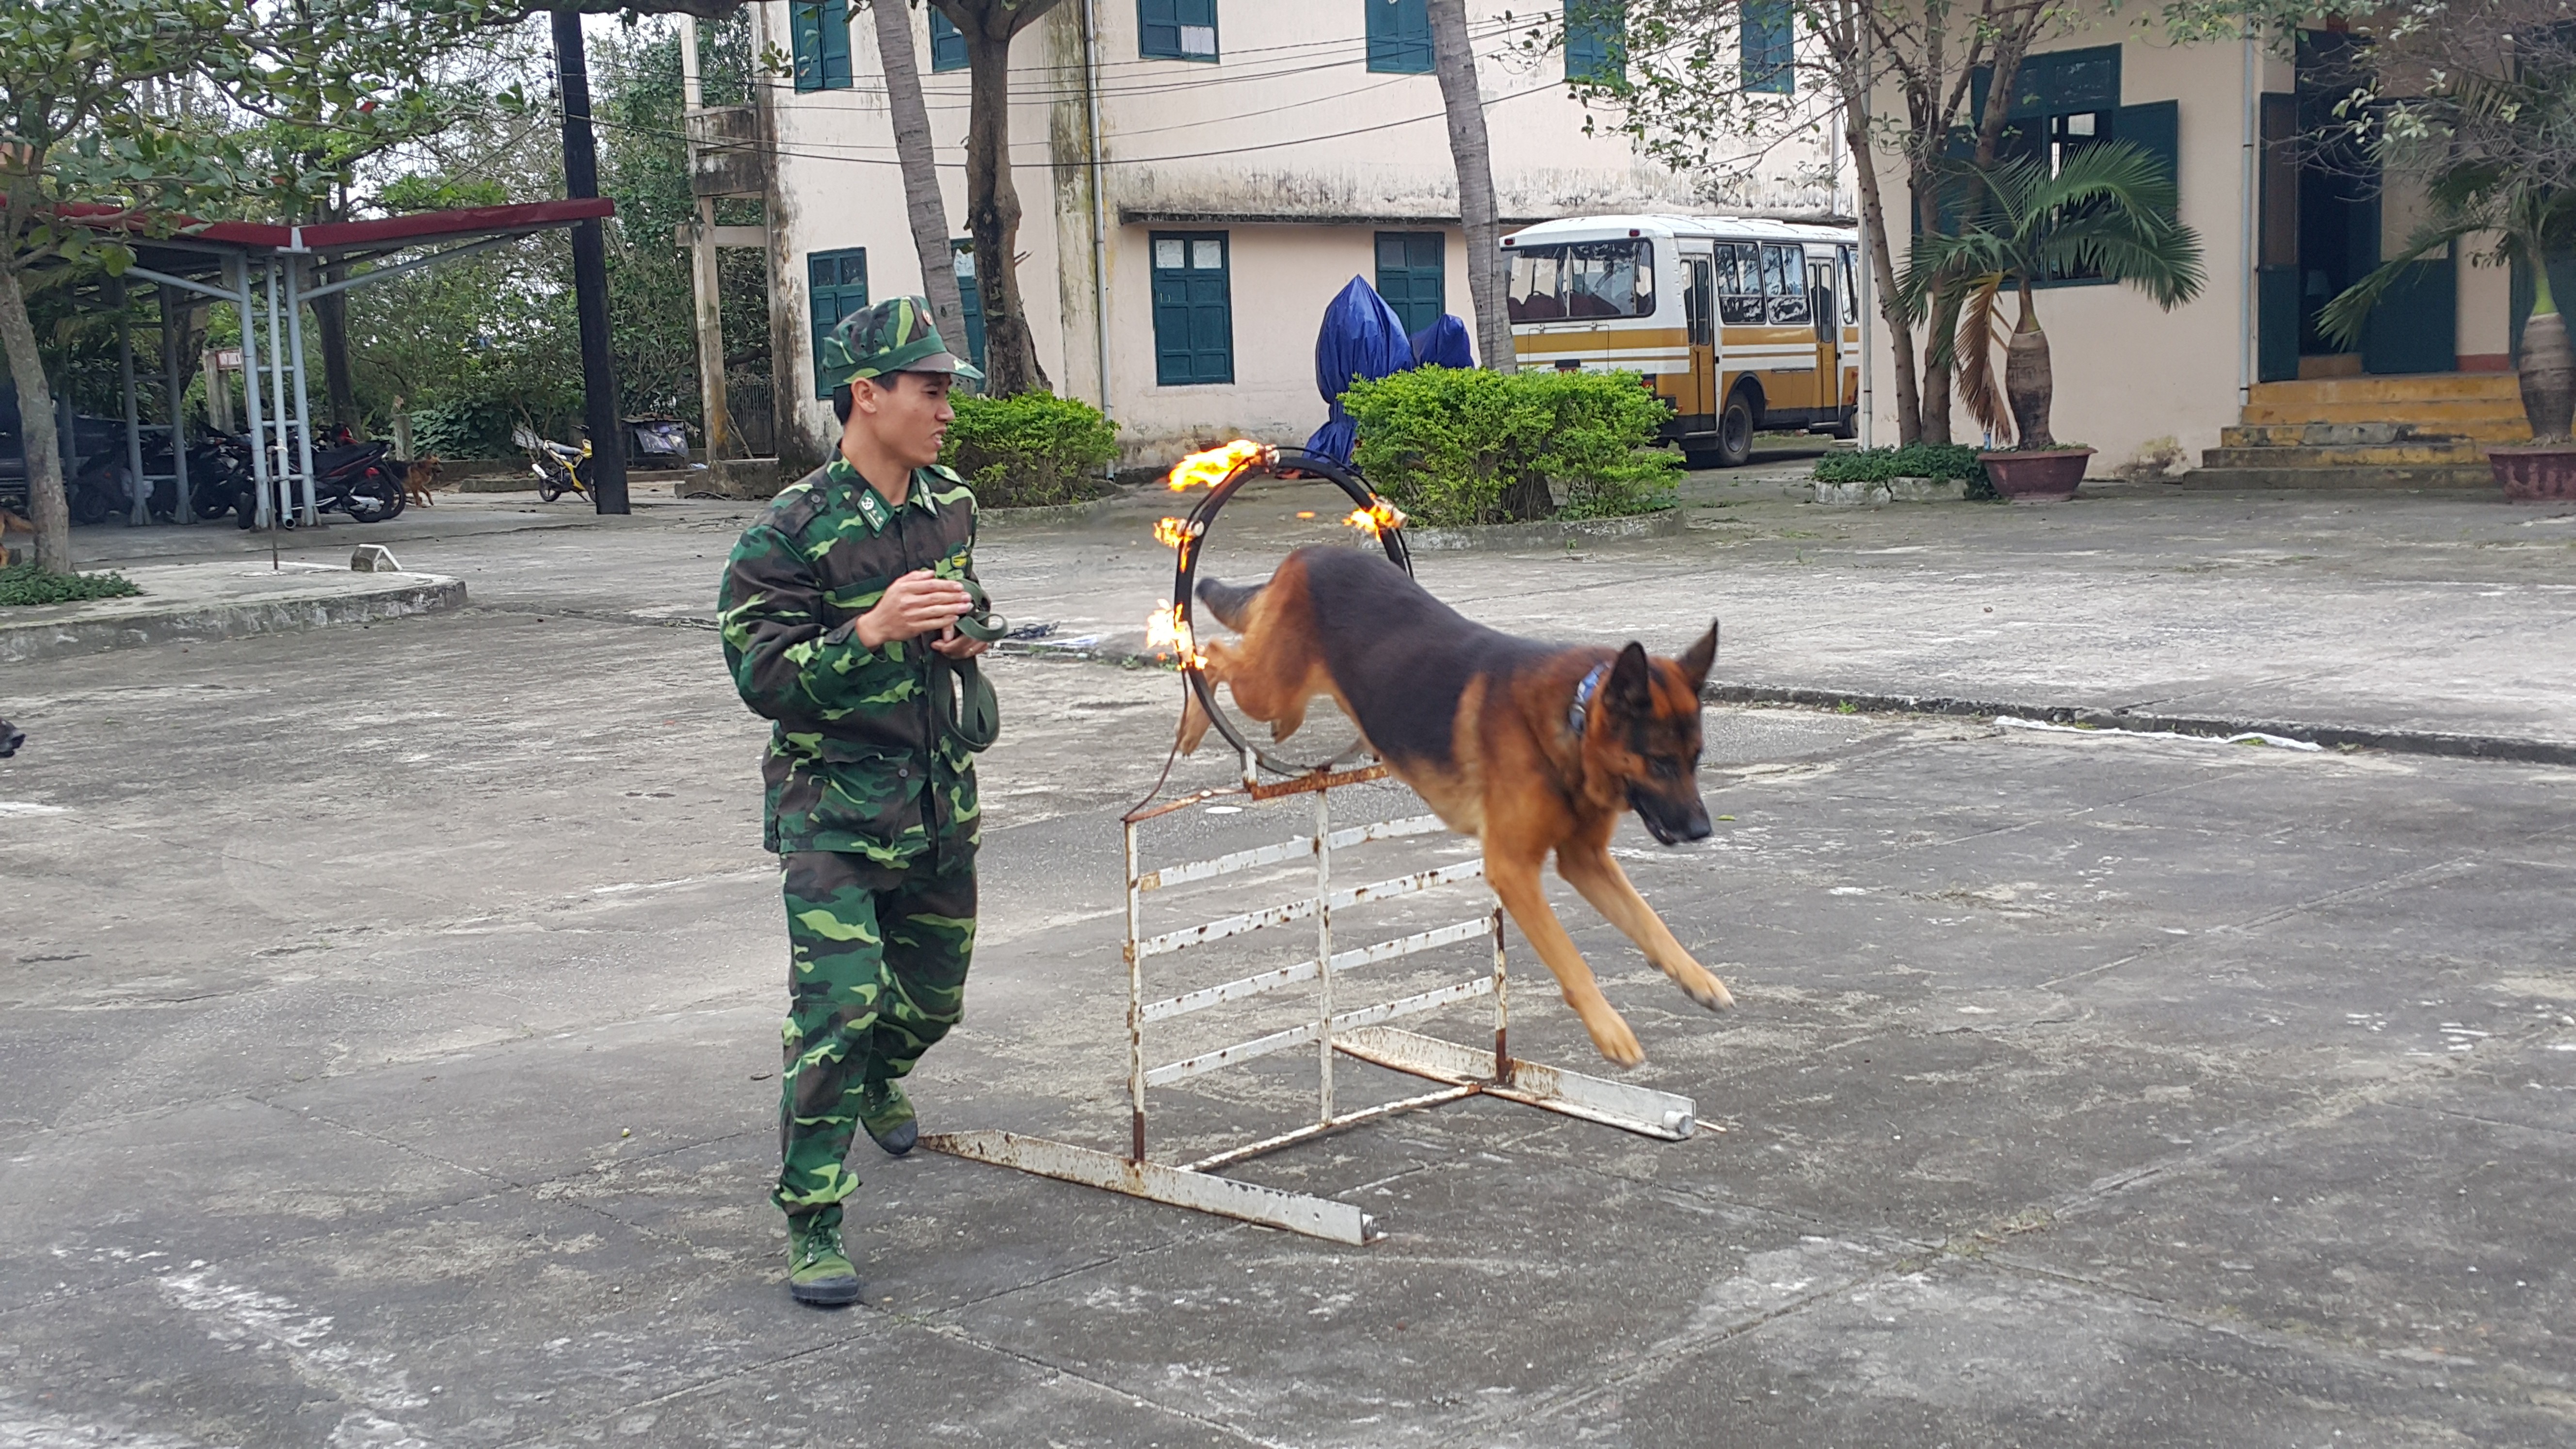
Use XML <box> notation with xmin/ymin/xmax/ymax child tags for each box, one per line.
<box><xmin>726</xmin><ymin>0</ymin><xmax>1850</xmax><ymax>459</ymax></box>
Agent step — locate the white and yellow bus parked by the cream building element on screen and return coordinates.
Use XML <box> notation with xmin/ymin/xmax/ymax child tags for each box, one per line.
<box><xmin>1502</xmin><ymin>217</ymin><xmax>1860</xmax><ymax>467</ymax></box>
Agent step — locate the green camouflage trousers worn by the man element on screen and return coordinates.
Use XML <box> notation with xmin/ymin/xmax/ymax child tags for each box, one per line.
<box><xmin>770</xmin><ymin>851</ymin><xmax>974</xmax><ymax>1214</ymax></box>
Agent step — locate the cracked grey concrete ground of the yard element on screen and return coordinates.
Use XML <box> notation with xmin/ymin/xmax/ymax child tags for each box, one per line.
<box><xmin>0</xmin><ymin>474</ymin><xmax>2576</xmax><ymax>1449</ymax></box>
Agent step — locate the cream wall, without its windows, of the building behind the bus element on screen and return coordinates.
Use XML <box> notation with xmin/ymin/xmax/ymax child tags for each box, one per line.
<box><xmin>760</xmin><ymin>0</ymin><xmax>1850</xmax><ymax>459</ymax></box>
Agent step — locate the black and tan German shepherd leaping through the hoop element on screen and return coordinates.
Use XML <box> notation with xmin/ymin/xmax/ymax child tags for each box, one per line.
<box><xmin>1180</xmin><ymin>547</ymin><xmax>1734</xmax><ymax>1067</ymax></box>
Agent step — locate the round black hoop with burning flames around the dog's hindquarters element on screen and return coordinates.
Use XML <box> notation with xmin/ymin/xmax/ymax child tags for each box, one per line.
<box><xmin>1146</xmin><ymin>438</ymin><xmax>1414</xmax><ymax>784</ymax></box>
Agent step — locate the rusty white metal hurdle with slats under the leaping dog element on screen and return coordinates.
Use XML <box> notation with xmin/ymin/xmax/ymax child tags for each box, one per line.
<box><xmin>922</xmin><ymin>758</ymin><xmax>1698</xmax><ymax>1243</ymax></box>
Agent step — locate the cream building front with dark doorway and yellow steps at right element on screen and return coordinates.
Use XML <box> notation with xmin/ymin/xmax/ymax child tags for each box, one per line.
<box><xmin>1870</xmin><ymin>16</ymin><xmax>2556</xmax><ymax>485</ymax></box>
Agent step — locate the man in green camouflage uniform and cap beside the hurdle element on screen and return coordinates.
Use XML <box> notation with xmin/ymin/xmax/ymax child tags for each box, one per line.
<box><xmin>719</xmin><ymin>296</ymin><xmax>989</xmax><ymax>1304</ymax></box>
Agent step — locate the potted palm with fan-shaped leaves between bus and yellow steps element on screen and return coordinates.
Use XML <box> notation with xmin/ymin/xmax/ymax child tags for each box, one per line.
<box><xmin>1901</xmin><ymin>142</ymin><xmax>2203</xmax><ymax>503</ymax></box>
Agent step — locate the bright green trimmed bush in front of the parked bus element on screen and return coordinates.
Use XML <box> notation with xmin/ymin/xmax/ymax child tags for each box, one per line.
<box><xmin>1342</xmin><ymin>366</ymin><xmax>1679</xmax><ymax>526</ymax></box>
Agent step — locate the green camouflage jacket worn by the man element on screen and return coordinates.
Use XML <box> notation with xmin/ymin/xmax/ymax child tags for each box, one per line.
<box><xmin>716</xmin><ymin>459</ymin><xmax>982</xmax><ymax>869</ymax></box>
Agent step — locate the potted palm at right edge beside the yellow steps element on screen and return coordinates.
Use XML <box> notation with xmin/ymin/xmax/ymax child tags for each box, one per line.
<box><xmin>2318</xmin><ymin>36</ymin><xmax>2576</xmax><ymax>500</ymax></box>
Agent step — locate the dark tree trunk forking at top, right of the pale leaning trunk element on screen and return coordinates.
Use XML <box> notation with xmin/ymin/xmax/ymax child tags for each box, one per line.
<box><xmin>933</xmin><ymin>0</ymin><xmax>1059</xmax><ymax>397</ymax></box>
